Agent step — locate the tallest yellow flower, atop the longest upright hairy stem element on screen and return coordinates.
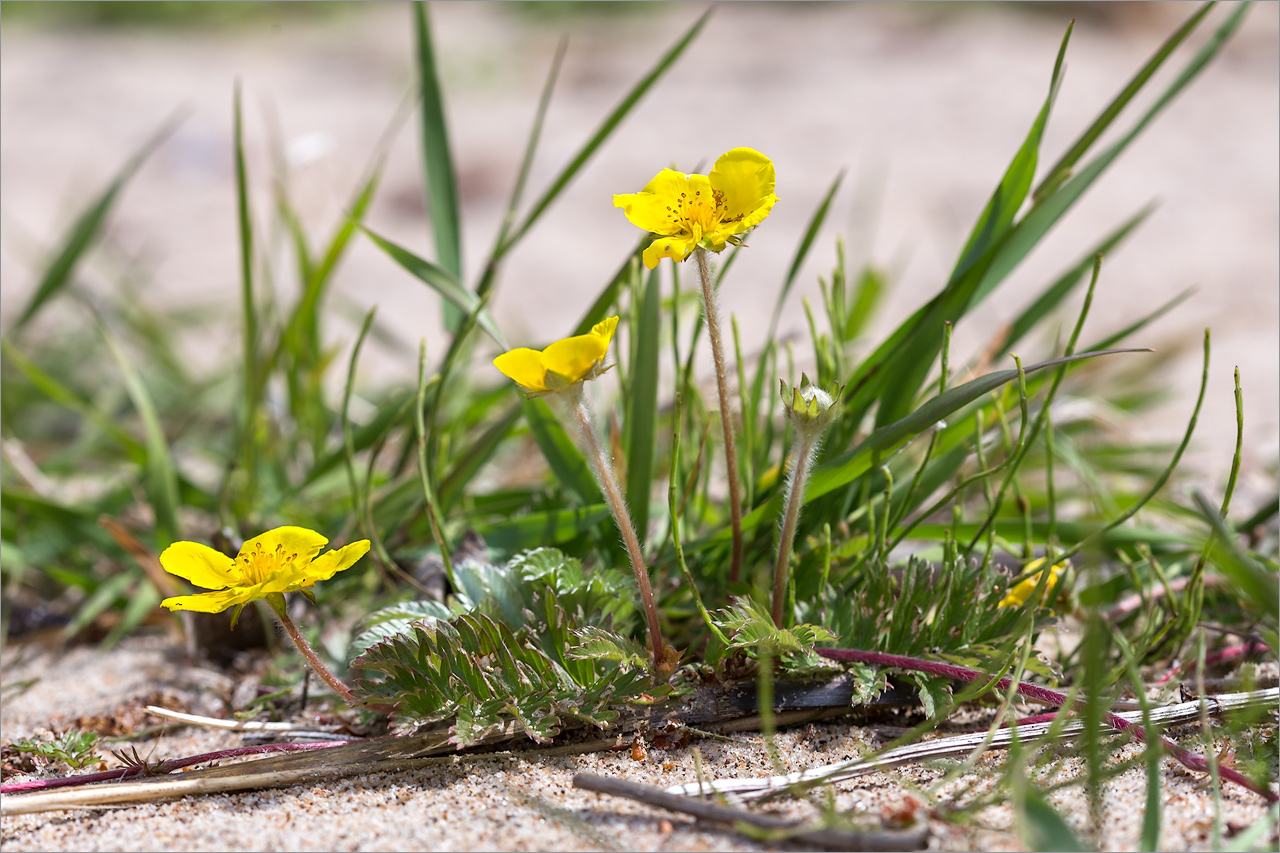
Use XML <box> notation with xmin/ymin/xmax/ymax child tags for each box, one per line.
<box><xmin>613</xmin><ymin>149</ymin><xmax>778</xmax><ymax>269</ymax></box>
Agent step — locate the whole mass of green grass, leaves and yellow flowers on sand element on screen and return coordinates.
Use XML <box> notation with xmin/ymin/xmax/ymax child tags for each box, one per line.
<box><xmin>0</xmin><ymin>4</ymin><xmax>1280</xmax><ymax>835</ymax></box>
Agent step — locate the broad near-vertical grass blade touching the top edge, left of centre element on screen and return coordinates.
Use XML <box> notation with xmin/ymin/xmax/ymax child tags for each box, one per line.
<box><xmin>413</xmin><ymin>1</ymin><xmax>466</xmax><ymax>285</ymax></box>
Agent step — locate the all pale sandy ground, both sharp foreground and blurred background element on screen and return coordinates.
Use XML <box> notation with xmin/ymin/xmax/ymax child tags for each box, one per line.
<box><xmin>0</xmin><ymin>3</ymin><xmax>1280</xmax><ymax>850</ymax></box>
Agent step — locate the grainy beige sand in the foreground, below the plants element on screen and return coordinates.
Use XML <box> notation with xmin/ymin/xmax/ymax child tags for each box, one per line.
<box><xmin>0</xmin><ymin>637</ymin><xmax>1276</xmax><ymax>850</ymax></box>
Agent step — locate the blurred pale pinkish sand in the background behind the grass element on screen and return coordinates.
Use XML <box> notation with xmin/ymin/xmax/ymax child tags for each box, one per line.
<box><xmin>0</xmin><ymin>3</ymin><xmax>1280</xmax><ymax>492</ymax></box>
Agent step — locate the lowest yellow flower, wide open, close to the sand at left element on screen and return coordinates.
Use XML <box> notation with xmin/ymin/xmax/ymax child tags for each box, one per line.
<box><xmin>160</xmin><ymin>528</ymin><xmax>369</xmax><ymax>625</ymax></box>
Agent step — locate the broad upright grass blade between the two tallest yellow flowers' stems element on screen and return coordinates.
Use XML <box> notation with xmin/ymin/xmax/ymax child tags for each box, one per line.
<box><xmin>626</xmin><ymin>263</ymin><xmax>662</xmax><ymax>539</ymax></box>
